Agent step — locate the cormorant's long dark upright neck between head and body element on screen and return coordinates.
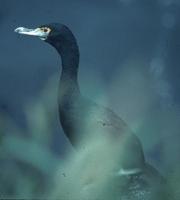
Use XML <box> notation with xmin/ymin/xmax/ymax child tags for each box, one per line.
<box><xmin>52</xmin><ymin>34</ymin><xmax>80</xmax><ymax>103</ymax></box>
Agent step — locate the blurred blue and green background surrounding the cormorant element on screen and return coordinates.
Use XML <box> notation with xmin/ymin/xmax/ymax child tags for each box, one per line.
<box><xmin>0</xmin><ymin>0</ymin><xmax>180</xmax><ymax>197</ymax></box>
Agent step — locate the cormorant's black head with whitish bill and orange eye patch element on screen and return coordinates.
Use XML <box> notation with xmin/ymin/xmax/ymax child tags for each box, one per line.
<box><xmin>14</xmin><ymin>23</ymin><xmax>79</xmax><ymax>66</ymax></box>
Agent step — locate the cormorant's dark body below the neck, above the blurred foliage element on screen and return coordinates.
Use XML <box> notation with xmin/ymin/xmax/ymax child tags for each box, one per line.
<box><xmin>59</xmin><ymin>90</ymin><xmax>144</xmax><ymax>159</ymax></box>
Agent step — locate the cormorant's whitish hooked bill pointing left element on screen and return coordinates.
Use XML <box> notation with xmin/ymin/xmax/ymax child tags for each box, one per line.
<box><xmin>14</xmin><ymin>27</ymin><xmax>49</xmax><ymax>40</ymax></box>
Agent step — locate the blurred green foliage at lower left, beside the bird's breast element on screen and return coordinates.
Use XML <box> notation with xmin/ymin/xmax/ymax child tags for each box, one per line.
<box><xmin>0</xmin><ymin>77</ymin><xmax>61</xmax><ymax>198</ymax></box>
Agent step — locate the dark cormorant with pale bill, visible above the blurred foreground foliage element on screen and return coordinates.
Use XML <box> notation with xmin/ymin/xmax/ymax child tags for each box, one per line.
<box><xmin>15</xmin><ymin>23</ymin><xmax>162</xmax><ymax>176</ymax></box>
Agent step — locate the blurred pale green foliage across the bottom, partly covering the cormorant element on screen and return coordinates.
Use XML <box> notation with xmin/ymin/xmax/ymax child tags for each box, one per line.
<box><xmin>0</xmin><ymin>77</ymin><xmax>180</xmax><ymax>200</ymax></box>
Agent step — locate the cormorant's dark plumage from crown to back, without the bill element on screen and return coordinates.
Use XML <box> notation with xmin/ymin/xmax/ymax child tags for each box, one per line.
<box><xmin>43</xmin><ymin>24</ymin><xmax>147</xmax><ymax>172</ymax></box>
